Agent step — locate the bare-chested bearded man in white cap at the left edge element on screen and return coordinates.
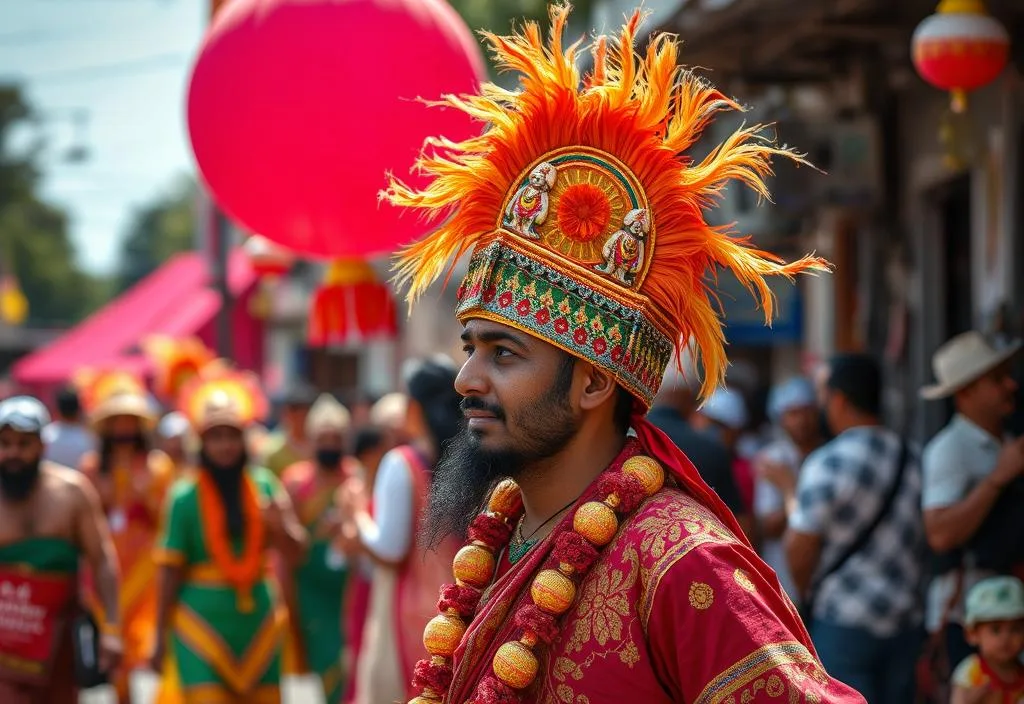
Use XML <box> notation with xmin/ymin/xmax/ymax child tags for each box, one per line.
<box><xmin>0</xmin><ymin>396</ymin><xmax>121</xmax><ymax>704</ymax></box>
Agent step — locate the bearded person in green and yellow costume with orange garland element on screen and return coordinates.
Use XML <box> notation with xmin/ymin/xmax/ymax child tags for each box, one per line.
<box><xmin>151</xmin><ymin>365</ymin><xmax>305</xmax><ymax>704</ymax></box>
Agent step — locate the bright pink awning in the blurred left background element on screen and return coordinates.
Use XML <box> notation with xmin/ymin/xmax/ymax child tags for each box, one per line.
<box><xmin>12</xmin><ymin>251</ymin><xmax>256</xmax><ymax>386</ymax></box>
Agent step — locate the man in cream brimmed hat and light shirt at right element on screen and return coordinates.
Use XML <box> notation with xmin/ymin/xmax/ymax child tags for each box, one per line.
<box><xmin>921</xmin><ymin>332</ymin><xmax>1024</xmax><ymax>663</ymax></box>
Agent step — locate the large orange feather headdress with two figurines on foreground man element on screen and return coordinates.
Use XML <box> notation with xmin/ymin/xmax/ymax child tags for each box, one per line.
<box><xmin>382</xmin><ymin>6</ymin><xmax>827</xmax><ymax>406</ymax></box>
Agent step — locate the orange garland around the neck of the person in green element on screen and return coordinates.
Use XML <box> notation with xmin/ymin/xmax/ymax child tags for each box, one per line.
<box><xmin>198</xmin><ymin>472</ymin><xmax>265</xmax><ymax>612</ymax></box>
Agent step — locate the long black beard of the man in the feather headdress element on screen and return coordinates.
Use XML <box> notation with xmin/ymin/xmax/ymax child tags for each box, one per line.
<box><xmin>422</xmin><ymin>354</ymin><xmax>580</xmax><ymax>546</ymax></box>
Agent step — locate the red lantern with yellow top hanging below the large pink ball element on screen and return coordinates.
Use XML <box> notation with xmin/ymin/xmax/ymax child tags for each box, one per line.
<box><xmin>307</xmin><ymin>259</ymin><xmax>398</xmax><ymax>347</ymax></box>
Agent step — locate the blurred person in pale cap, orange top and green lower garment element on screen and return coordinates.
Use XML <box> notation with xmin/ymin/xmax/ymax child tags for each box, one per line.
<box><xmin>283</xmin><ymin>394</ymin><xmax>353</xmax><ymax>704</ymax></box>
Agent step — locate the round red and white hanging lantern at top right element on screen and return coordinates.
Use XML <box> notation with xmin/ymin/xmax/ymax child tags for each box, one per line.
<box><xmin>912</xmin><ymin>0</ymin><xmax>1010</xmax><ymax>113</ymax></box>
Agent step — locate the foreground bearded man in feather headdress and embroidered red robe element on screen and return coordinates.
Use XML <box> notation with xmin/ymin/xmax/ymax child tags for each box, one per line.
<box><xmin>386</xmin><ymin>7</ymin><xmax>863</xmax><ymax>704</ymax></box>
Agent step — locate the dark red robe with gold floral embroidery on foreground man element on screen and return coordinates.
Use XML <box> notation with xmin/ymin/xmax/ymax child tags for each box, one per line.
<box><xmin>445</xmin><ymin>429</ymin><xmax>864</xmax><ymax>704</ymax></box>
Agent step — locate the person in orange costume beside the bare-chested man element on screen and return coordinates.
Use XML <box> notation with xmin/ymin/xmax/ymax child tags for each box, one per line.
<box><xmin>80</xmin><ymin>371</ymin><xmax>175</xmax><ymax>703</ymax></box>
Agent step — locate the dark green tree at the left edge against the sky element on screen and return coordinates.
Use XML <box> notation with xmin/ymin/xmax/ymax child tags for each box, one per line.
<box><xmin>0</xmin><ymin>86</ymin><xmax>106</xmax><ymax>326</ymax></box>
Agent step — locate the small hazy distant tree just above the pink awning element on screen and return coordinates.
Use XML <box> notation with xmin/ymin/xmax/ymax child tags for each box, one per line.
<box><xmin>115</xmin><ymin>176</ymin><xmax>197</xmax><ymax>293</ymax></box>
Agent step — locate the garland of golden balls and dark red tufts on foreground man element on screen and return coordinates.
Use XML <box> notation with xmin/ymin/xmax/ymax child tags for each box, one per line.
<box><xmin>409</xmin><ymin>454</ymin><xmax>665</xmax><ymax>704</ymax></box>
